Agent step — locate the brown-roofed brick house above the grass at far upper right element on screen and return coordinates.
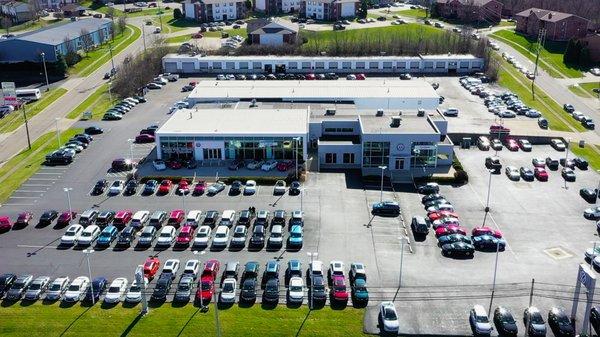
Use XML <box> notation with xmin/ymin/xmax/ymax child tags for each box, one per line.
<box><xmin>515</xmin><ymin>8</ymin><xmax>590</xmax><ymax>41</ymax></box>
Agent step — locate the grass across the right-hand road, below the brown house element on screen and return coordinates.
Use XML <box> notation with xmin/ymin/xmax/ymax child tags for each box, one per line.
<box><xmin>491</xmin><ymin>30</ymin><xmax>583</xmax><ymax>78</ymax></box>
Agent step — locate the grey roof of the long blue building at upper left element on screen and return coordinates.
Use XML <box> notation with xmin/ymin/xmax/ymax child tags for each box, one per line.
<box><xmin>14</xmin><ymin>18</ymin><xmax>111</xmax><ymax>45</ymax></box>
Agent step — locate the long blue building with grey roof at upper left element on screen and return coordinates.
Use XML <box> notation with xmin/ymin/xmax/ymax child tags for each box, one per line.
<box><xmin>0</xmin><ymin>18</ymin><xmax>112</xmax><ymax>63</ymax></box>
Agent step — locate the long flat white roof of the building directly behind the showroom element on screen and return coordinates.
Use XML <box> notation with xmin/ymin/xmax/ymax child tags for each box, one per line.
<box><xmin>188</xmin><ymin>79</ymin><xmax>439</xmax><ymax>102</ymax></box>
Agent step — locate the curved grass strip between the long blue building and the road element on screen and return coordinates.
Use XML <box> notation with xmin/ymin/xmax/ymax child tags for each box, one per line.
<box><xmin>69</xmin><ymin>25</ymin><xmax>142</xmax><ymax>77</ymax></box>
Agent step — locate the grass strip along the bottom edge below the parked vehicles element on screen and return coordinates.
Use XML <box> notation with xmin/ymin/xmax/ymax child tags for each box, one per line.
<box><xmin>0</xmin><ymin>303</ymin><xmax>364</xmax><ymax>337</ymax></box>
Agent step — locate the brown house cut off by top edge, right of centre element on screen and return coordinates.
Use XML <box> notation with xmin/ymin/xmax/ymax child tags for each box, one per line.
<box><xmin>435</xmin><ymin>0</ymin><xmax>503</xmax><ymax>24</ymax></box>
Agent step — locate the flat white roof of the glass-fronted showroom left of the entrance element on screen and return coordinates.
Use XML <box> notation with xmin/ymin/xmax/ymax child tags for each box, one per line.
<box><xmin>156</xmin><ymin>108</ymin><xmax>309</xmax><ymax>136</ymax></box>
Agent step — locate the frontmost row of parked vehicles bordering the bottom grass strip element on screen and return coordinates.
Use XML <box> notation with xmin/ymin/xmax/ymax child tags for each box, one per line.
<box><xmin>0</xmin><ymin>256</ymin><xmax>369</xmax><ymax>306</ymax></box>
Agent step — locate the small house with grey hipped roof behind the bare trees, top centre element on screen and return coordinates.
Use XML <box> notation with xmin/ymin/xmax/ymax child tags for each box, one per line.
<box><xmin>247</xmin><ymin>19</ymin><xmax>299</xmax><ymax>46</ymax></box>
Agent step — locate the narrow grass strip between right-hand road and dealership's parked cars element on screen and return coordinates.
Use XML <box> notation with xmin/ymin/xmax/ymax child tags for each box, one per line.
<box><xmin>498</xmin><ymin>58</ymin><xmax>586</xmax><ymax>131</ymax></box>
